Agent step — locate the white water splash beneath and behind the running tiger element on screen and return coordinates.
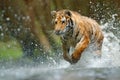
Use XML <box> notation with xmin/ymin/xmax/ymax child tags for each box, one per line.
<box><xmin>54</xmin><ymin>14</ymin><xmax>120</xmax><ymax>68</ymax></box>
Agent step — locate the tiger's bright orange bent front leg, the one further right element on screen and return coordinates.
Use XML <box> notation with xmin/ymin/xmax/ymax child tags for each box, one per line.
<box><xmin>71</xmin><ymin>36</ymin><xmax>90</xmax><ymax>64</ymax></box>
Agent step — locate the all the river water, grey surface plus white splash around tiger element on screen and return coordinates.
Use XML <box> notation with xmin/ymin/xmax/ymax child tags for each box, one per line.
<box><xmin>0</xmin><ymin>15</ymin><xmax>120</xmax><ymax>80</ymax></box>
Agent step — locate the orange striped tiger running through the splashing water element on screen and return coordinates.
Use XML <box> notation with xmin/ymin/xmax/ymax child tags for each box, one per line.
<box><xmin>51</xmin><ymin>9</ymin><xmax>104</xmax><ymax>64</ymax></box>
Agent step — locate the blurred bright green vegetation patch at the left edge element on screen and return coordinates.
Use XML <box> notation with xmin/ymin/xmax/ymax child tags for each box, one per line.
<box><xmin>0</xmin><ymin>40</ymin><xmax>22</xmax><ymax>60</ymax></box>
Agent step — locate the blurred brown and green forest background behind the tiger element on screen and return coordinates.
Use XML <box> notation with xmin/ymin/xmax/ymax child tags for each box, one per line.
<box><xmin>0</xmin><ymin>0</ymin><xmax>120</xmax><ymax>62</ymax></box>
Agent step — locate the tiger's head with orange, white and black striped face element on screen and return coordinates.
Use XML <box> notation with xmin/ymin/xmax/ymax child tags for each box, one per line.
<box><xmin>51</xmin><ymin>10</ymin><xmax>73</xmax><ymax>35</ymax></box>
